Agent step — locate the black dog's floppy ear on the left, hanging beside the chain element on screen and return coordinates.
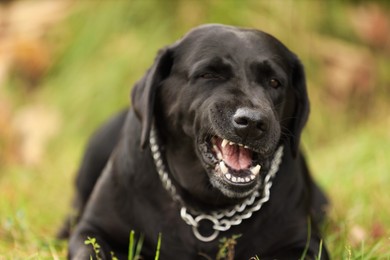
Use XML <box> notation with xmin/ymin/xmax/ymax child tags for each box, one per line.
<box><xmin>131</xmin><ymin>48</ymin><xmax>173</xmax><ymax>149</ymax></box>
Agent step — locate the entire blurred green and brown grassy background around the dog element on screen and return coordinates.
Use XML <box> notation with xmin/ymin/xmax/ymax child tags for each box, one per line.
<box><xmin>0</xmin><ymin>0</ymin><xmax>390</xmax><ymax>259</ymax></box>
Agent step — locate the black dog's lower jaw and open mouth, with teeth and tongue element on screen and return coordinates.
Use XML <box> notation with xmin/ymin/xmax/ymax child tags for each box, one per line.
<box><xmin>198</xmin><ymin>136</ymin><xmax>275</xmax><ymax>199</ymax></box>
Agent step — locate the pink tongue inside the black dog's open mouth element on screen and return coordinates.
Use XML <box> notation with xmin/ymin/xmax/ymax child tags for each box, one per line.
<box><xmin>218</xmin><ymin>139</ymin><xmax>252</xmax><ymax>170</ymax></box>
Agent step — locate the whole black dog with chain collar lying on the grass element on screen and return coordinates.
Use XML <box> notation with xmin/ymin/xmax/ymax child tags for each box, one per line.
<box><xmin>62</xmin><ymin>25</ymin><xmax>328</xmax><ymax>259</ymax></box>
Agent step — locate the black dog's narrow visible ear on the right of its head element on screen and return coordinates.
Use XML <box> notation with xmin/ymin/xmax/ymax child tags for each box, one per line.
<box><xmin>290</xmin><ymin>57</ymin><xmax>310</xmax><ymax>157</ymax></box>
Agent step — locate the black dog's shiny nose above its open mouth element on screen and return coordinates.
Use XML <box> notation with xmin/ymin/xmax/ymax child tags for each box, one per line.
<box><xmin>233</xmin><ymin>108</ymin><xmax>269</xmax><ymax>138</ymax></box>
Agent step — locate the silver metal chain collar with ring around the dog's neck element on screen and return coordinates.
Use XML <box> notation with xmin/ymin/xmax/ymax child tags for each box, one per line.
<box><xmin>149</xmin><ymin>126</ymin><xmax>283</xmax><ymax>242</ymax></box>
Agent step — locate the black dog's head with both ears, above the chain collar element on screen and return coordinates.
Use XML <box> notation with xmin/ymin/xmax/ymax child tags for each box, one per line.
<box><xmin>132</xmin><ymin>25</ymin><xmax>309</xmax><ymax>203</ymax></box>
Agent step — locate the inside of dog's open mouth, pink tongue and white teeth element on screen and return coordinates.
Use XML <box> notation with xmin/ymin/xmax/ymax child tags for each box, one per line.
<box><xmin>210</xmin><ymin>136</ymin><xmax>261</xmax><ymax>184</ymax></box>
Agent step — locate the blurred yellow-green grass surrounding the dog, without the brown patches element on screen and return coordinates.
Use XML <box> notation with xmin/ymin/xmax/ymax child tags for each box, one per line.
<box><xmin>0</xmin><ymin>0</ymin><xmax>390</xmax><ymax>259</ymax></box>
